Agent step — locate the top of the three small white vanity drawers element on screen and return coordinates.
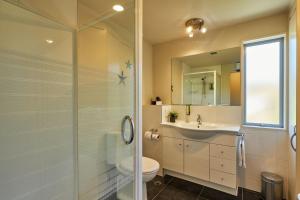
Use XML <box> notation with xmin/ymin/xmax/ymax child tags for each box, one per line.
<box><xmin>210</xmin><ymin>144</ymin><xmax>236</xmax><ymax>160</ymax></box>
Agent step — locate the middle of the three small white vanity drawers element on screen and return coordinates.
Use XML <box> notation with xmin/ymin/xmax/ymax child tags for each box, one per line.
<box><xmin>210</xmin><ymin>157</ymin><xmax>236</xmax><ymax>174</ymax></box>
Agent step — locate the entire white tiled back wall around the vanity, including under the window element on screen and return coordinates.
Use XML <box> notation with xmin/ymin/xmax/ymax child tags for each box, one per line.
<box><xmin>143</xmin><ymin>105</ymin><xmax>289</xmax><ymax>197</ymax></box>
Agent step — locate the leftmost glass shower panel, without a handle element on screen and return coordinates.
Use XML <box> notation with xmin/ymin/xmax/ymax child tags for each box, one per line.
<box><xmin>0</xmin><ymin>0</ymin><xmax>75</xmax><ymax>200</ymax></box>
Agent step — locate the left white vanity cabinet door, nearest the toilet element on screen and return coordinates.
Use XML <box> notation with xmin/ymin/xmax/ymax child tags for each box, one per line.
<box><xmin>163</xmin><ymin>137</ymin><xmax>183</xmax><ymax>173</ymax></box>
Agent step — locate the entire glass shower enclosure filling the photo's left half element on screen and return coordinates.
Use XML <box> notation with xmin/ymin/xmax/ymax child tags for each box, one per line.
<box><xmin>0</xmin><ymin>0</ymin><xmax>142</xmax><ymax>200</ymax></box>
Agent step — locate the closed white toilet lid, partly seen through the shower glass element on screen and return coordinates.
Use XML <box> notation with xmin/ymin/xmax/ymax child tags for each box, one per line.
<box><xmin>119</xmin><ymin>157</ymin><xmax>159</xmax><ymax>174</ymax></box>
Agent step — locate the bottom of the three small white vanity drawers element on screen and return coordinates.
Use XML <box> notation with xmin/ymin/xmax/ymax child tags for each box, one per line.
<box><xmin>210</xmin><ymin>170</ymin><xmax>236</xmax><ymax>188</ymax></box>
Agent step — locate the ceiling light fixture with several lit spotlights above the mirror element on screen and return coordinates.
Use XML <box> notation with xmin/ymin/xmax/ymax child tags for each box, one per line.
<box><xmin>185</xmin><ymin>18</ymin><xmax>207</xmax><ymax>38</ymax></box>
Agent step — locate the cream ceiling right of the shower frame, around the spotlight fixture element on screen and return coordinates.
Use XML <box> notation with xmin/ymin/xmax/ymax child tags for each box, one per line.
<box><xmin>143</xmin><ymin>0</ymin><xmax>293</xmax><ymax>44</ymax></box>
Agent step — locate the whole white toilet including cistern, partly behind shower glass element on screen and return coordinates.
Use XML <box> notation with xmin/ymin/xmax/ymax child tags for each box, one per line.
<box><xmin>106</xmin><ymin>132</ymin><xmax>159</xmax><ymax>200</ymax></box>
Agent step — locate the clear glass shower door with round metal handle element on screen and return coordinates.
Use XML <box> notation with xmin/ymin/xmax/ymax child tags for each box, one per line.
<box><xmin>77</xmin><ymin>0</ymin><xmax>141</xmax><ymax>200</ymax></box>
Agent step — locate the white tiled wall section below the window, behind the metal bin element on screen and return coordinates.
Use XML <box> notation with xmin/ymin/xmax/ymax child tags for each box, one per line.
<box><xmin>240</xmin><ymin>128</ymin><xmax>289</xmax><ymax>197</ymax></box>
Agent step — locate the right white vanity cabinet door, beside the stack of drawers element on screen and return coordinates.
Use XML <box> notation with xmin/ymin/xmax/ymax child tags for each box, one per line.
<box><xmin>183</xmin><ymin>140</ymin><xmax>209</xmax><ymax>180</ymax></box>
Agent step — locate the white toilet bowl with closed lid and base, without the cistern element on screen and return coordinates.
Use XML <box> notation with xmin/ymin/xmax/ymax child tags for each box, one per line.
<box><xmin>117</xmin><ymin>157</ymin><xmax>159</xmax><ymax>200</ymax></box>
